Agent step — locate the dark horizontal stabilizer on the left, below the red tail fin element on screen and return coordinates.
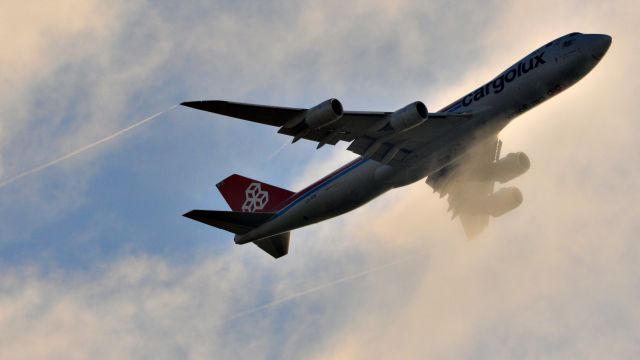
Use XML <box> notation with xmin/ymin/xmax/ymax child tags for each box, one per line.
<box><xmin>183</xmin><ymin>210</ymin><xmax>274</xmax><ymax>234</ymax></box>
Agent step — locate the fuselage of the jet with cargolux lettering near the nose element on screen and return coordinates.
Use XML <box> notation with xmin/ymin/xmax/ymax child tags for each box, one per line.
<box><xmin>235</xmin><ymin>33</ymin><xmax>611</xmax><ymax>244</ymax></box>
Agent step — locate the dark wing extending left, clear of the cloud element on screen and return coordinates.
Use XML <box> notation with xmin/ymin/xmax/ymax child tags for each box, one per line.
<box><xmin>182</xmin><ymin>99</ymin><xmax>470</xmax><ymax>166</ymax></box>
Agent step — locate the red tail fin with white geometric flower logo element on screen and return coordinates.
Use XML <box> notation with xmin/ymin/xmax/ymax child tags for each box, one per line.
<box><xmin>216</xmin><ymin>174</ymin><xmax>294</xmax><ymax>212</ymax></box>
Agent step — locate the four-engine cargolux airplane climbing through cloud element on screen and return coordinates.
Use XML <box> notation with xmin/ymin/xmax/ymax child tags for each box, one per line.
<box><xmin>181</xmin><ymin>32</ymin><xmax>611</xmax><ymax>258</ymax></box>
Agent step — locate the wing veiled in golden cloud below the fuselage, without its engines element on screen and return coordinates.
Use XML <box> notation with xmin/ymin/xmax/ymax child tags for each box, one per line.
<box><xmin>427</xmin><ymin>136</ymin><xmax>502</xmax><ymax>238</ymax></box>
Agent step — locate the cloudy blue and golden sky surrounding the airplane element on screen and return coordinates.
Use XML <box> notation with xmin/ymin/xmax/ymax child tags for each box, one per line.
<box><xmin>0</xmin><ymin>0</ymin><xmax>640</xmax><ymax>359</ymax></box>
